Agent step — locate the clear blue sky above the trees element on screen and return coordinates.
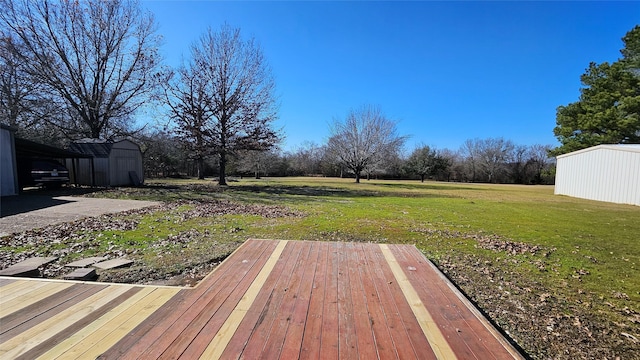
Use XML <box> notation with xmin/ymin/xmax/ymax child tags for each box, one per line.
<box><xmin>142</xmin><ymin>1</ymin><xmax>640</xmax><ymax>151</ymax></box>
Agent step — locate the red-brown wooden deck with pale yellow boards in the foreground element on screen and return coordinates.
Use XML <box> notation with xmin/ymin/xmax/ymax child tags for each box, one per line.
<box><xmin>0</xmin><ymin>240</ymin><xmax>522</xmax><ymax>359</ymax></box>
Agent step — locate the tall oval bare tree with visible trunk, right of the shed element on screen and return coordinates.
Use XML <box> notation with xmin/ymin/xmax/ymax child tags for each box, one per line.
<box><xmin>176</xmin><ymin>25</ymin><xmax>279</xmax><ymax>185</ymax></box>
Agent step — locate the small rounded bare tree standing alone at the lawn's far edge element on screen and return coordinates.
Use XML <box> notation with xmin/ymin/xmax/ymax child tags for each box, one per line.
<box><xmin>328</xmin><ymin>105</ymin><xmax>406</xmax><ymax>183</ymax></box>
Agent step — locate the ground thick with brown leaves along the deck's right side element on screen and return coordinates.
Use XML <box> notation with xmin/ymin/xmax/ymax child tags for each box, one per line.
<box><xmin>437</xmin><ymin>252</ymin><xmax>640</xmax><ymax>360</ymax></box>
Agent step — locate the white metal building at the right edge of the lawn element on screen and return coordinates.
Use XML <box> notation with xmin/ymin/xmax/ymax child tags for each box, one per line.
<box><xmin>555</xmin><ymin>144</ymin><xmax>640</xmax><ymax>206</ymax></box>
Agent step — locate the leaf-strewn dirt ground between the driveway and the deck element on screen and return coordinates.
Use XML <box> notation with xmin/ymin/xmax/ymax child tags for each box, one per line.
<box><xmin>0</xmin><ymin>200</ymin><xmax>302</xmax><ymax>286</ymax></box>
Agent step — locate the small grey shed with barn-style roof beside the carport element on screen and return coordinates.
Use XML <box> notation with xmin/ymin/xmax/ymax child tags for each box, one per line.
<box><xmin>67</xmin><ymin>139</ymin><xmax>144</xmax><ymax>187</ymax></box>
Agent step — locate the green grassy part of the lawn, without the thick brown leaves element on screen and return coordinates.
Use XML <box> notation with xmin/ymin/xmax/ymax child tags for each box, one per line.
<box><xmin>105</xmin><ymin>178</ymin><xmax>640</xmax><ymax>310</ymax></box>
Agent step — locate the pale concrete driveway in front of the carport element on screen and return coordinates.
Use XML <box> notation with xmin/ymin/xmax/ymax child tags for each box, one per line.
<box><xmin>0</xmin><ymin>195</ymin><xmax>159</xmax><ymax>237</ymax></box>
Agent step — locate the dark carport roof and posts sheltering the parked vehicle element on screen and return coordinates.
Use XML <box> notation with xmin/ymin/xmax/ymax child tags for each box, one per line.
<box><xmin>15</xmin><ymin>138</ymin><xmax>95</xmax><ymax>185</ymax></box>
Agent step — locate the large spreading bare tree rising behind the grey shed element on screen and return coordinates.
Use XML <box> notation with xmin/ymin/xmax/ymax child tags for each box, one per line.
<box><xmin>0</xmin><ymin>0</ymin><xmax>159</xmax><ymax>138</ymax></box>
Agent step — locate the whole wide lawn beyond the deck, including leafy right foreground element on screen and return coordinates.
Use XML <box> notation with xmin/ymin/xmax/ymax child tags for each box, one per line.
<box><xmin>21</xmin><ymin>178</ymin><xmax>640</xmax><ymax>358</ymax></box>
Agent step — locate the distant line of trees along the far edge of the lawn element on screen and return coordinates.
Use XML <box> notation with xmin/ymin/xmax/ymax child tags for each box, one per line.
<box><xmin>143</xmin><ymin>132</ymin><xmax>555</xmax><ymax>184</ymax></box>
